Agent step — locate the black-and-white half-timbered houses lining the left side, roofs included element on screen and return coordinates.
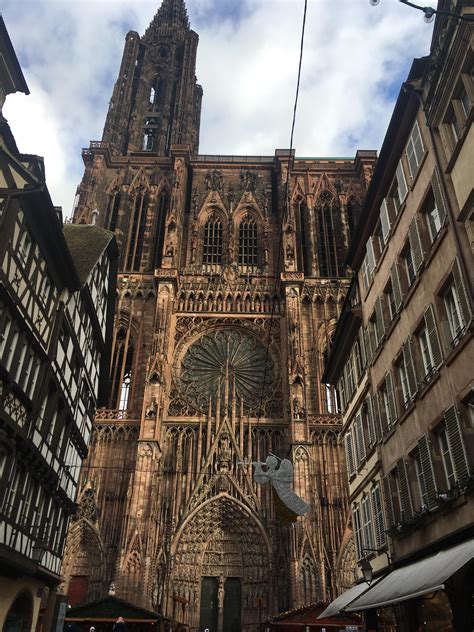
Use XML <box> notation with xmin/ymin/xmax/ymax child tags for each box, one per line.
<box><xmin>0</xmin><ymin>22</ymin><xmax>116</xmax><ymax>631</ymax></box>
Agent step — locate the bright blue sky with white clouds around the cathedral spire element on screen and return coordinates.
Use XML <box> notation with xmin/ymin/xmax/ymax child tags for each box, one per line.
<box><xmin>2</xmin><ymin>0</ymin><xmax>436</xmax><ymax>216</ymax></box>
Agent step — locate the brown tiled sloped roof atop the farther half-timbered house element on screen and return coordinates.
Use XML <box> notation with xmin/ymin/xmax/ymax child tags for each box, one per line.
<box><xmin>63</xmin><ymin>224</ymin><xmax>114</xmax><ymax>286</ymax></box>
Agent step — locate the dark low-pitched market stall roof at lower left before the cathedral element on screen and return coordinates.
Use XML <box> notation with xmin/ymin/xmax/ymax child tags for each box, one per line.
<box><xmin>66</xmin><ymin>595</ymin><xmax>164</xmax><ymax>623</ymax></box>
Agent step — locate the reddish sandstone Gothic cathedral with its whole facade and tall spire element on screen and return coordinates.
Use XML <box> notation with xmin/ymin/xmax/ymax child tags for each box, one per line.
<box><xmin>63</xmin><ymin>0</ymin><xmax>376</xmax><ymax>632</ymax></box>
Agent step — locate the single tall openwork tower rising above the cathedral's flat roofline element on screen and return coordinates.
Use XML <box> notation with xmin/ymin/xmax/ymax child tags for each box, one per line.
<box><xmin>102</xmin><ymin>0</ymin><xmax>202</xmax><ymax>156</ymax></box>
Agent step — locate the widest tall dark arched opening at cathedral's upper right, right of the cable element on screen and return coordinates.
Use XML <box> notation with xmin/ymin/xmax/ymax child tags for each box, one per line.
<box><xmin>316</xmin><ymin>191</ymin><xmax>345</xmax><ymax>277</ymax></box>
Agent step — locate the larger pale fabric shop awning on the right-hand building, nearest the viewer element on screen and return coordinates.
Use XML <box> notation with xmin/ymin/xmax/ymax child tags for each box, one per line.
<box><xmin>344</xmin><ymin>539</ymin><xmax>474</xmax><ymax>612</ymax></box>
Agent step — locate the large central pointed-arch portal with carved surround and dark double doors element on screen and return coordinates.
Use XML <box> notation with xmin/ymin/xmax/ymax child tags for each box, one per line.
<box><xmin>168</xmin><ymin>492</ymin><xmax>272</xmax><ymax>632</ymax></box>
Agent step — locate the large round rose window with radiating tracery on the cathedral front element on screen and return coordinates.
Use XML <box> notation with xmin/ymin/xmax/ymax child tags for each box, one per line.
<box><xmin>179</xmin><ymin>329</ymin><xmax>274</xmax><ymax>413</ymax></box>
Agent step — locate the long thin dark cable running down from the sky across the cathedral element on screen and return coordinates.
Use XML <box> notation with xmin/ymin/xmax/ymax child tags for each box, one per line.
<box><xmin>257</xmin><ymin>0</ymin><xmax>308</xmax><ymax>426</ymax></box>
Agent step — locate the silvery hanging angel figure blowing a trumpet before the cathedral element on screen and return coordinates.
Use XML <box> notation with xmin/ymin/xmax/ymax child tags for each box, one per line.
<box><xmin>253</xmin><ymin>454</ymin><xmax>309</xmax><ymax>522</ymax></box>
